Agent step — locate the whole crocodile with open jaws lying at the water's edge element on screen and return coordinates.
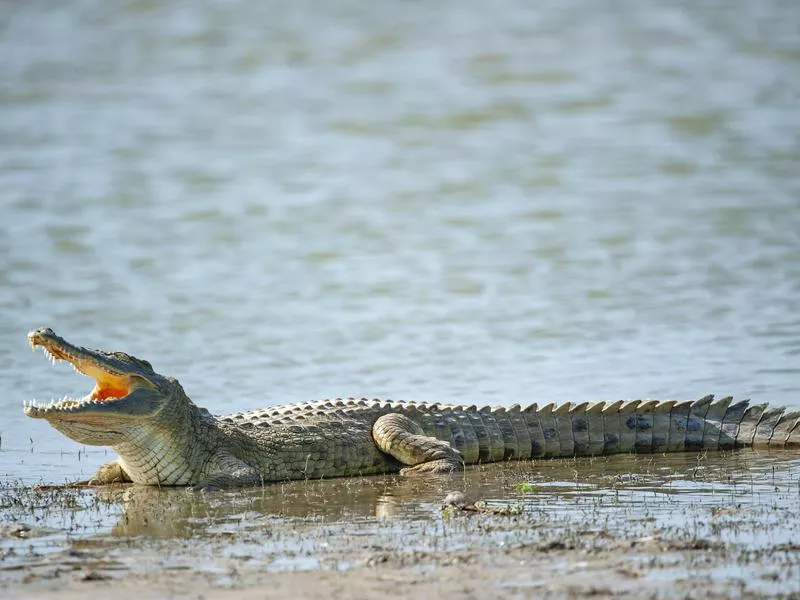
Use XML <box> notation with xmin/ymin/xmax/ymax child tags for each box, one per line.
<box><xmin>24</xmin><ymin>328</ymin><xmax>800</xmax><ymax>490</ymax></box>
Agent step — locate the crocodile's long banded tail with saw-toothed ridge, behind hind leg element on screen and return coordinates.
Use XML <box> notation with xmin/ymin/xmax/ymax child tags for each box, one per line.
<box><xmin>428</xmin><ymin>396</ymin><xmax>800</xmax><ymax>464</ymax></box>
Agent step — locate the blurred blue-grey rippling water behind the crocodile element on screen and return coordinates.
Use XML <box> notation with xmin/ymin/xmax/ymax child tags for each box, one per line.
<box><xmin>0</xmin><ymin>0</ymin><xmax>800</xmax><ymax>480</ymax></box>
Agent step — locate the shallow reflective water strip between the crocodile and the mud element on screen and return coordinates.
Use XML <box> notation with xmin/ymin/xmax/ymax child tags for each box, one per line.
<box><xmin>6</xmin><ymin>449</ymin><xmax>800</xmax><ymax>547</ymax></box>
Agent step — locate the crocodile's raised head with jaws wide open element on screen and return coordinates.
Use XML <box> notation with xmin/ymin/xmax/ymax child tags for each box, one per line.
<box><xmin>24</xmin><ymin>328</ymin><xmax>185</xmax><ymax>446</ymax></box>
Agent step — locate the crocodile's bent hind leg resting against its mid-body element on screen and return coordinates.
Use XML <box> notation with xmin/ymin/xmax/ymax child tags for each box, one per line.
<box><xmin>372</xmin><ymin>413</ymin><xmax>464</xmax><ymax>475</ymax></box>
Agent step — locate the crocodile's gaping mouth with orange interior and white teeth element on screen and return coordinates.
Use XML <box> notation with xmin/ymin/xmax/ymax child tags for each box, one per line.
<box><xmin>25</xmin><ymin>329</ymin><xmax>132</xmax><ymax>414</ymax></box>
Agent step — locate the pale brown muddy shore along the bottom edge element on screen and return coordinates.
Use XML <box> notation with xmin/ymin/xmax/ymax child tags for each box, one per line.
<box><xmin>8</xmin><ymin>539</ymin><xmax>799</xmax><ymax>599</ymax></box>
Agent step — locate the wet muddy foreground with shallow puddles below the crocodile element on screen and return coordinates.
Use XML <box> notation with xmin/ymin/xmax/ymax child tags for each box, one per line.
<box><xmin>0</xmin><ymin>450</ymin><xmax>800</xmax><ymax>598</ymax></box>
